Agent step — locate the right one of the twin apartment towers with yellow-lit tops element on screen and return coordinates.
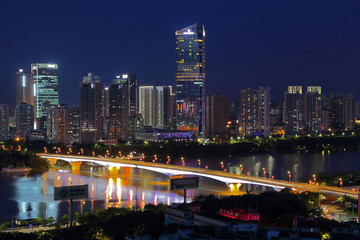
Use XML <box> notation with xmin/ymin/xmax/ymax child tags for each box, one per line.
<box><xmin>303</xmin><ymin>86</ymin><xmax>322</xmax><ymax>134</ymax></box>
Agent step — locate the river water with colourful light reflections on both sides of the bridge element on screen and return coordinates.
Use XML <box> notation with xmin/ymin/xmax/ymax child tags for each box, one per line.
<box><xmin>0</xmin><ymin>152</ymin><xmax>360</xmax><ymax>222</ymax></box>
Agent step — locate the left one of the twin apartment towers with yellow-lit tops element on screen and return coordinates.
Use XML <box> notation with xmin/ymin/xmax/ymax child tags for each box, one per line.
<box><xmin>284</xmin><ymin>86</ymin><xmax>303</xmax><ymax>135</ymax></box>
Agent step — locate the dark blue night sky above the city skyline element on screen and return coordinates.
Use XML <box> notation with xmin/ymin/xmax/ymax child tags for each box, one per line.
<box><xmin>0</xmin><ymin>0</ymin><xmax>360</xmax><ymax>106</ymax></box>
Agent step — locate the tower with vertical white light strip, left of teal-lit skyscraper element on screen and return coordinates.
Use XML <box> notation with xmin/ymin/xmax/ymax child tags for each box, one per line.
<box><xmin>16</xmin><ymin>69</ymin><xmax>35</xmax><ymax>106</ymax></box>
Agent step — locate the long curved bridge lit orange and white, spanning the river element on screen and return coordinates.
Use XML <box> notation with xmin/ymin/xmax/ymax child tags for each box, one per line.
<box><xmin>38</xmin><ymin>154</ymin><xmax>358</xmax><ymax>198</ymax></box>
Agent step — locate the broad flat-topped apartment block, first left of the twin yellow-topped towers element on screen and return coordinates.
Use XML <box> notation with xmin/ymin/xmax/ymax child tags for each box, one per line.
<box><xmin>239</xmin><ymin>87</ymin><xmax>270</xmax><ymax>137</ymax></box>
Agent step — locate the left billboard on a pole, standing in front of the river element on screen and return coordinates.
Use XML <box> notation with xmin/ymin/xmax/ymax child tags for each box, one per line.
<box><xmin>54</xmin><ymin>184</ymin><xmax>89</xmax><ymax>201</ymax></box>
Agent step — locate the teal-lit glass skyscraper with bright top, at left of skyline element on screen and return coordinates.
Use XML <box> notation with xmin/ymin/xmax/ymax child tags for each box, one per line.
<box><xmin>31</xmin><ymin>63</ymin><xmax>59</xmax><ymax>130</ymax></box>
